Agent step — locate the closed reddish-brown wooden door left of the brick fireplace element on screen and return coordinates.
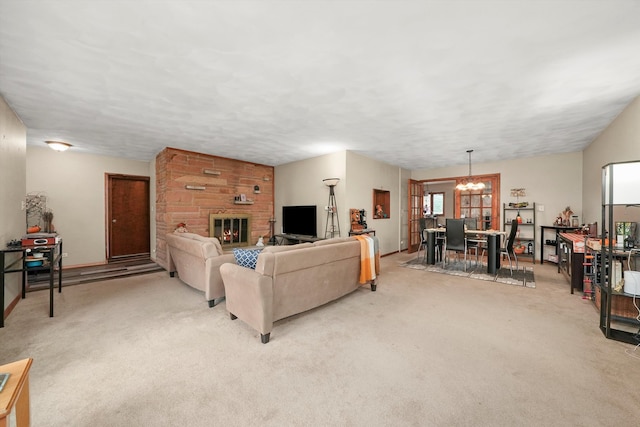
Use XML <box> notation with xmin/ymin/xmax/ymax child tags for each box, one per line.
<box><xmin>106</xmin><ymin>174</ymin><xmax>151</xmax><ymax>261</ymax></box>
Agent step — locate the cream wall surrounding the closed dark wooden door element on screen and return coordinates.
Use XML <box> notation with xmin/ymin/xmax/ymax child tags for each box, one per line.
<box><xmin>22</xmin><ymin>147</ymin><xmax>149</xmax><ymax>267</ymax></box>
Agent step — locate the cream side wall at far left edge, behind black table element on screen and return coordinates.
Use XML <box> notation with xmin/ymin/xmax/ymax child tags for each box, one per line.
<box><xmin>0</xmin><ymin>96</ymin><xmax>27</xmax><ymax>313</ymax></box>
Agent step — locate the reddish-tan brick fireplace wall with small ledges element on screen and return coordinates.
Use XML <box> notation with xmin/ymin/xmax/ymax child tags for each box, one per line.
<box><xmin>155</xmin><ymin>147</ymin><xmax>274</xmax><ymax>268</ymax></box>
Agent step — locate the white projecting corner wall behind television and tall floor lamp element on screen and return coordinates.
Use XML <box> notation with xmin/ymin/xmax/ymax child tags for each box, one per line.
<box><xmin>275</xmin><ymin>151</ymin><xmax>409</xmax><ymax>254</ymax></box>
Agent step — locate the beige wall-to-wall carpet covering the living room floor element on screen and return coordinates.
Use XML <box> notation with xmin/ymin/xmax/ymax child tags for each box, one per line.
<box><xmin>0</xmin><ymin>254</ymin><xmax>640</xmax><ymax>427</ymax></box>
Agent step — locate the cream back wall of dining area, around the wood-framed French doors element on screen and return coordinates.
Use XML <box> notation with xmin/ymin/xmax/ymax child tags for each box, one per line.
<box><xmin>411</xmin><ymin>152</ymin><xmax>591</xmax><ymax>260</ymax></box>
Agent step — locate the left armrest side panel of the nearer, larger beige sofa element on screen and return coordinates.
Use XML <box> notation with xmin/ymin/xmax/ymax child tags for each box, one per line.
<box><xmin>220</xmin><ymin>263</ymin><xmax>273</xmax><ymax>335</ymax></box>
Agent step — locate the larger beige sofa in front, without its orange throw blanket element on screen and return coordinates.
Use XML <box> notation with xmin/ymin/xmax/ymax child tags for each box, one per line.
<box><xmin>220</xmin><ymin>237</ymin><xmax>379</xmax><ymax>344</ymax></box>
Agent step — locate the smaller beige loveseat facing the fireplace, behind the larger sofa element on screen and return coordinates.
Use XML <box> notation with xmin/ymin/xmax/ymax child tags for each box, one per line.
<box><xmin>166</xmin><ymin>233</ymin><xmax>235</xmax><ymax>307</ymax></box>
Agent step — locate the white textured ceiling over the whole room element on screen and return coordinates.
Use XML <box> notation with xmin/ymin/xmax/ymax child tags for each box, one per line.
<box><xmin>0</xmin><ymin>0</ymin><xmax>640</xmax><ymax>169</ymax></box>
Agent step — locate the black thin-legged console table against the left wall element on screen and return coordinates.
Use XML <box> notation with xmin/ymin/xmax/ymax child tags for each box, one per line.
<box><xmin>0</xmin><ymin>240</ymin><xmax>62</xmax><ymax>328</ymax></box>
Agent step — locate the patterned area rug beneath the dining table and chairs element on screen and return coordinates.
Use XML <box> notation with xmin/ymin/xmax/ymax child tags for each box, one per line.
<box><xmin>402</xmin><ymin>259</ymin><xmax>536</xmax><ymax>288</ymax></box>
